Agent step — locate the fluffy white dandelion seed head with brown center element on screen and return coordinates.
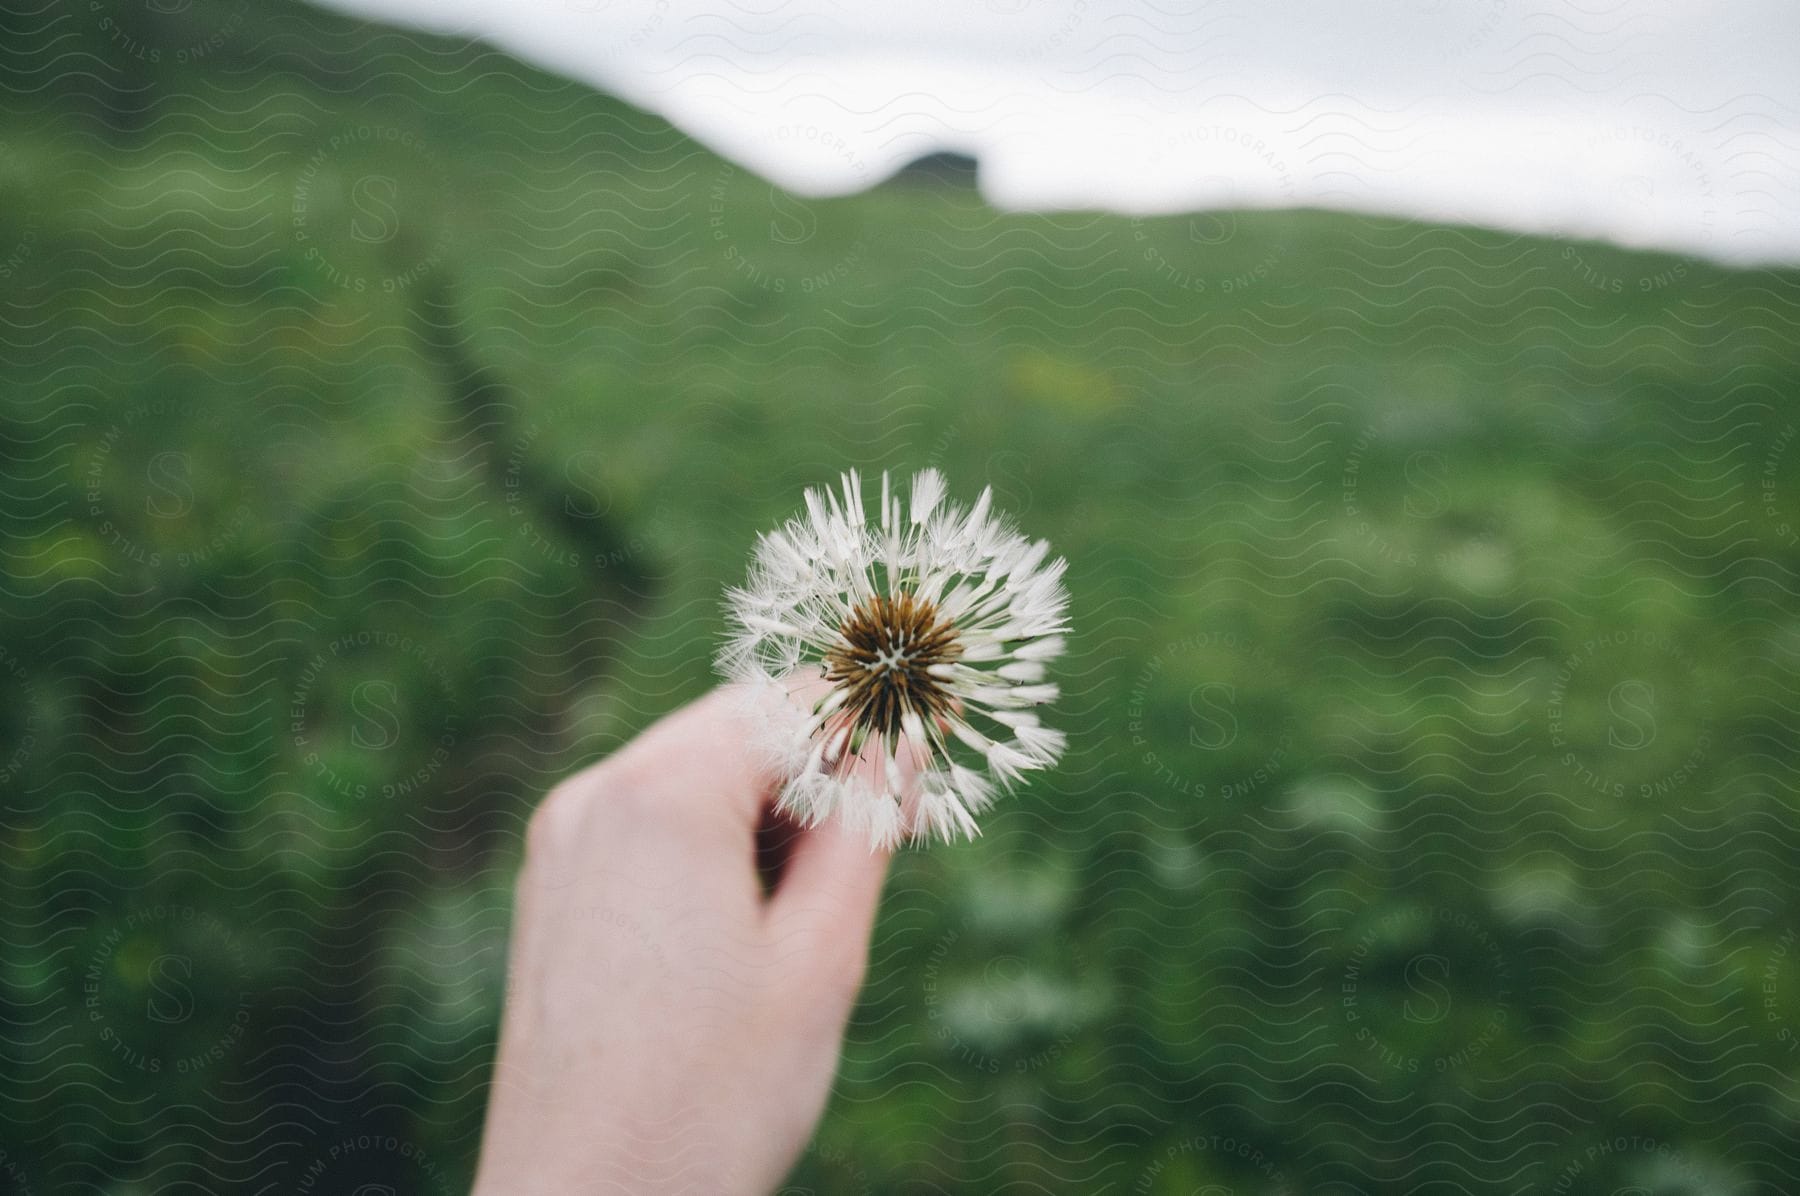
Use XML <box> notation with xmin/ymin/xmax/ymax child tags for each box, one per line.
<box><xmin>718</xmin><ymin>470</ymin><xmax>1069</xmax><ymax>847</ymax></box>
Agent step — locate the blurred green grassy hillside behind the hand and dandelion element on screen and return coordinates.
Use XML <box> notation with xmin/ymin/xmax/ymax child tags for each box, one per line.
<box><xmin>0</xmin><ymin>0</ymin><xmax>1800</xmax><ymax>1196</ymax></box>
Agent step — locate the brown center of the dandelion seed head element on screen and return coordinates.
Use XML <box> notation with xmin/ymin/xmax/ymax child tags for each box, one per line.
<box><xmin>824</xmin><ymin>591</ymin><xmax>963</xmax><ymax>737</ymax></box>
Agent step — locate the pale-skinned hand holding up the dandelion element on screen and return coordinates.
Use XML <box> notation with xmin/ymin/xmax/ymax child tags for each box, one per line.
<box><xmin>475</xmin><ymin>690</ymin><xmax>887</xmax><ymax>1196</ymax></box>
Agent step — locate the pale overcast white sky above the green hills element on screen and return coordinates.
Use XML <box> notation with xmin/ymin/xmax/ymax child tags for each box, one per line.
<box><xmin>313</xmin><ymin>0</ymin><xmax>1800</xmax><ymax>265</ymax></box>
